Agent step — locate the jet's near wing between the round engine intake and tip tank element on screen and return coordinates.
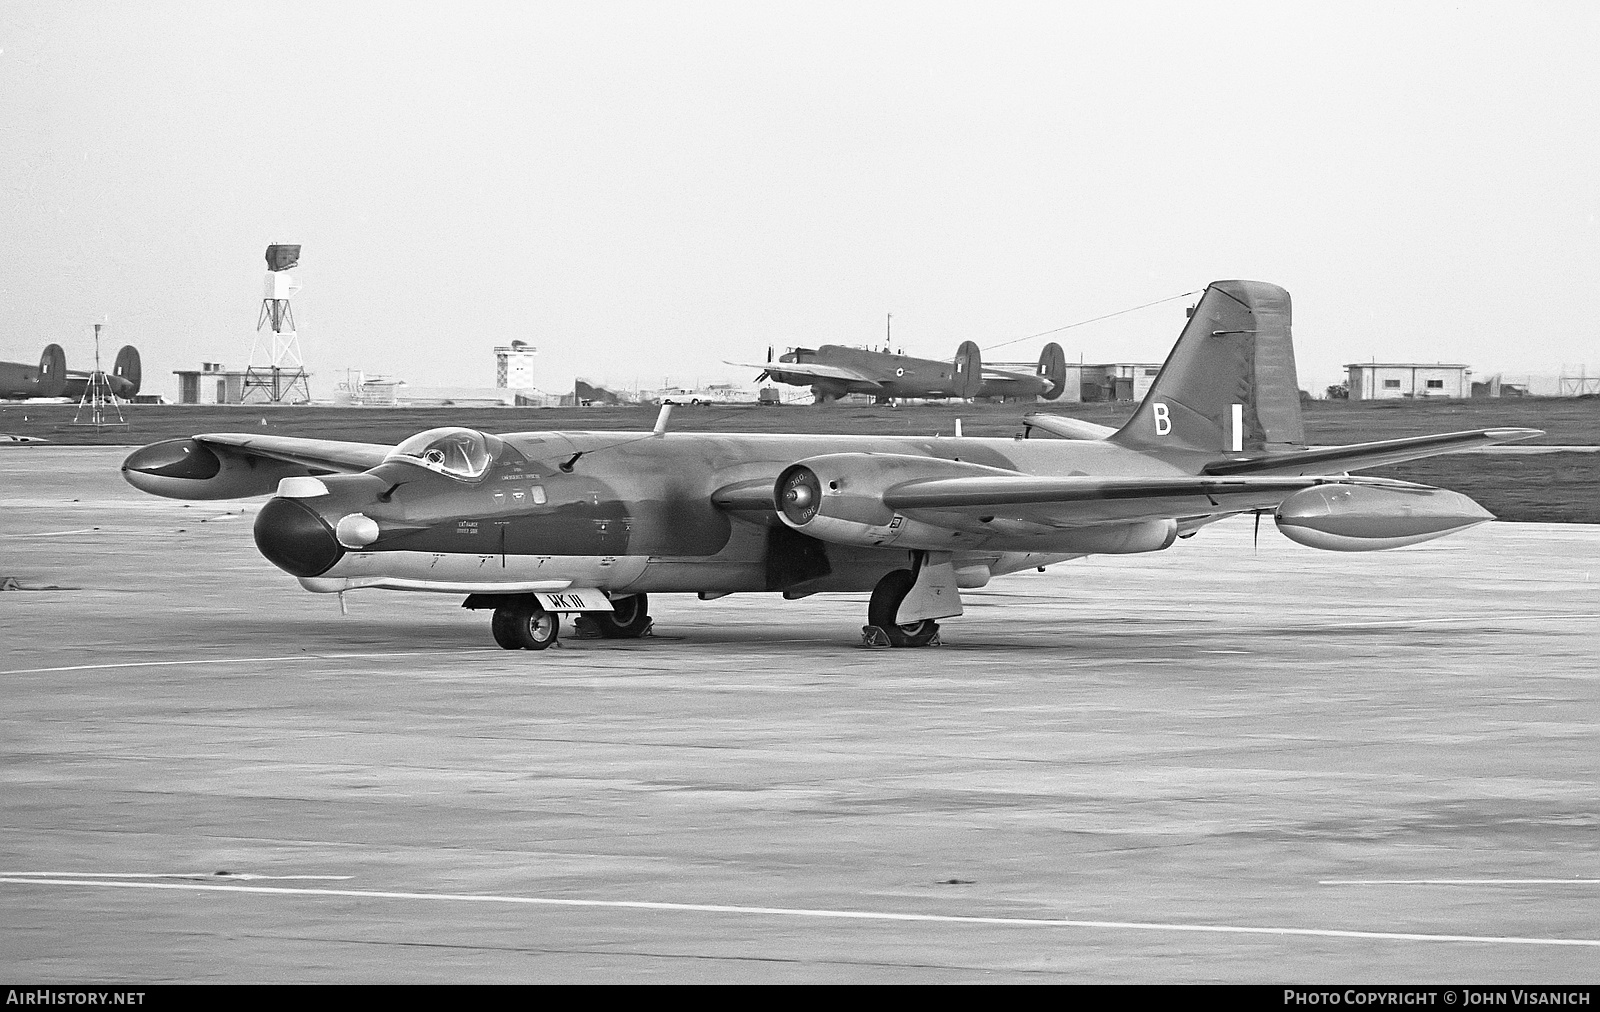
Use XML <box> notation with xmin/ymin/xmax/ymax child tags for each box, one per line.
<box><xmin>883</xmin><ymin>474</ymin><xmax>1328</xmax><ymax>528</ymax></box>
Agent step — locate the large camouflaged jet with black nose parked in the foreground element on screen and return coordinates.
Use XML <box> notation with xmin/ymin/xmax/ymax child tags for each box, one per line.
<box><xmin>122</xmin><ymin>282</ymin><xmax>1539</xmax><ymax>650</ymax></box>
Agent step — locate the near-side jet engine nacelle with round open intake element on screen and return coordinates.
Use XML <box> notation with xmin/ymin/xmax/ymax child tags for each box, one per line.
<box><xmin>773</xmin><ymin>453</ymin><xmax>1013</xmax><ymax>551</ymax></box>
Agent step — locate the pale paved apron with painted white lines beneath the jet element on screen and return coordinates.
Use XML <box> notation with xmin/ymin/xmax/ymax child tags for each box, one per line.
<box><xmin>0</xmin><ymin>447</ymin><xmax>1600</xmax><ymax>983</ymax></box>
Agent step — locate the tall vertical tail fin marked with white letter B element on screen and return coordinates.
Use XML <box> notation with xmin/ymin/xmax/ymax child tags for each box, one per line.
<box><xmin>1110</xmin><ymin>282</ymin><xmax>1306</xmax><ymax>453</ymax></box>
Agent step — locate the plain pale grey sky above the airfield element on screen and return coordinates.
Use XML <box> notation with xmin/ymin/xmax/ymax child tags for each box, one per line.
<box><xmin>0</xmin><ymin>0</ymin><xmax>1600</xmax><ymax>397</ymax></box>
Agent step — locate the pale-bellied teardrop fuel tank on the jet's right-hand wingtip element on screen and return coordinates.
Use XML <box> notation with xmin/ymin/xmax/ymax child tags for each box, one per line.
<box><xmin>1274</xmin><ymin>485</ymin><xmax>1494</xmax><ymax>552</ymax></box>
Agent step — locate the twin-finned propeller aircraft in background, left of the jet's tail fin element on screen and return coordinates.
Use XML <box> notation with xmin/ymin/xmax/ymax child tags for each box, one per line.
<box><xmin>728</xmin><ymin>341</ymin><xmax>1067</xmax><ymax>404</ymax></box>
